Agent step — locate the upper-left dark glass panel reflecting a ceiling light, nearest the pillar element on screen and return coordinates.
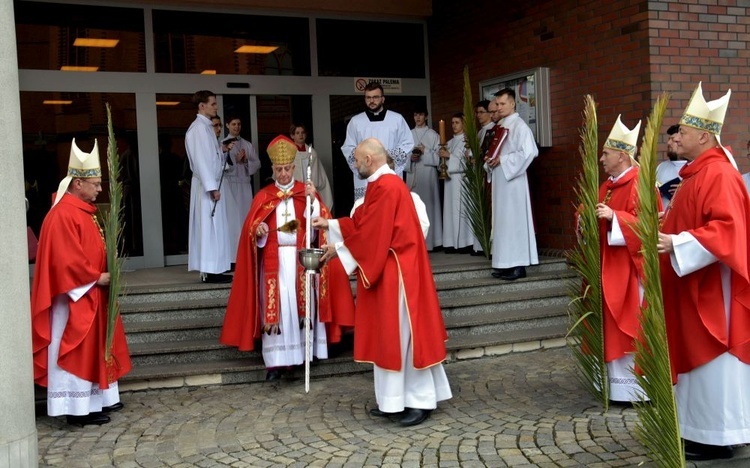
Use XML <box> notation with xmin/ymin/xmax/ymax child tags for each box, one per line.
<box><xmin>14</xmin><ymin>2</ymin><xmax>146</xmax><ymax>72</ymax></box>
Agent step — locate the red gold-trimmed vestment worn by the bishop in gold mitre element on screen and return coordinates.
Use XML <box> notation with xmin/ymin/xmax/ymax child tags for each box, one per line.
<box><xmin>219</xmin><ymin>182</ymin><xmax>354</xmax><ymax>351</ymax></box>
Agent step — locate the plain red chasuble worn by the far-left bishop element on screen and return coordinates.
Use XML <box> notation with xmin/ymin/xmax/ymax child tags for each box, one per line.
<box><xmin>31</xmin><ymin>193</ymin><xmax>131</xmax><ymax>389</ymax></box>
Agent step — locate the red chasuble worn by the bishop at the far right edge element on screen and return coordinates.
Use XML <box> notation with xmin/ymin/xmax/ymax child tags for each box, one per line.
<box><xmin>660</xmin><ymin>148</ymin><xmax>750</xmax><ymax>380</ymax></box>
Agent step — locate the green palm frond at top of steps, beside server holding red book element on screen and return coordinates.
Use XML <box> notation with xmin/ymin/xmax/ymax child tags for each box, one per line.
<box><xmin>461</xmin><ymin>66</ymin><xmax>492</xmax><ymax>258</ymax></box>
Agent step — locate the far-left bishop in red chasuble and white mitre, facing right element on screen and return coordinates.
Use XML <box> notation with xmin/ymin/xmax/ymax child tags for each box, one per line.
<box><xmin>31</xmin><ymin>139</ymin><xmax>131</xmax><ymax>426</ymax></box>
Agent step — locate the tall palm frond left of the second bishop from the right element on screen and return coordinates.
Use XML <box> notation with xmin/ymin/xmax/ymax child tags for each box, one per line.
<box><xmin>567</xmin><ymin>95</ymin><xmax>609</xmax><ymax>411</ymax></box>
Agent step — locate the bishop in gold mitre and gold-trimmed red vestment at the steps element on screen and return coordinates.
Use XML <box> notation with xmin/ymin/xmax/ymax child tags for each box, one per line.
<box><xmin>220</xmin><ymin>136</ymin><xmax>354</xmax><ymax>380</ymax></box>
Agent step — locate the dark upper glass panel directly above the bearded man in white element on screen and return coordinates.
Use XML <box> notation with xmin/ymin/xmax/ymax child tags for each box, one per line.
<box><xmin>316</xmin><ymin>19</ymin><xmax>425</xmax><ymax>78</ymax></box>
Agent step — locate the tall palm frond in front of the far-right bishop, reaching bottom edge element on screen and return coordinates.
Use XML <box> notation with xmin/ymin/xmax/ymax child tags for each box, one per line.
<box><xmin>635</xmin><ymin>94</ymin><xmax>685</xmax><ymax>467</ymax></box>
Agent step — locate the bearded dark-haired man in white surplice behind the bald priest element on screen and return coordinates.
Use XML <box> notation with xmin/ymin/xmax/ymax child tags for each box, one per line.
<box><xmin>341</xmin><ymin>82</ymin><xmax>414</xmax><ymax>200</ymax></box>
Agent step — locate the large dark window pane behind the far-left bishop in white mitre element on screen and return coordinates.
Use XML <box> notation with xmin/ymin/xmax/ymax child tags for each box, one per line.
<box><xmin>21</xmin><ymin>91</ymin><xmax>143</xmax><ymax>257</ymax></box>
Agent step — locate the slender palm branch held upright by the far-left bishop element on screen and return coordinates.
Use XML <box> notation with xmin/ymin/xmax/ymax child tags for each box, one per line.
<box><xmin>103</xmin><ymin>103</ymin><xmax>124</xmax><ymax>369</ymax></box>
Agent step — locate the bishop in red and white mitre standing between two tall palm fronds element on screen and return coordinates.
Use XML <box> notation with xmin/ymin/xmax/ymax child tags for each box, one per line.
<box><xmin>596</xmin><ymin>116</ymin><xmax>661</xmax><ymax>402</ymax></box>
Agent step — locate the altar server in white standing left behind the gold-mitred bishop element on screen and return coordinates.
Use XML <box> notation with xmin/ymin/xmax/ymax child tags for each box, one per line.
<box><xmin>222</xmin><ymin>116</ymin><xmax>260</xmax><ymax>263</ymax></box>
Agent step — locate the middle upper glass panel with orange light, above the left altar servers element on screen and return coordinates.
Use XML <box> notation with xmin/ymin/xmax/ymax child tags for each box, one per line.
<box><xmin>153</xmin><ymin>10</ymin><xmax>310</xmax><ymax>76</ymax></box>
